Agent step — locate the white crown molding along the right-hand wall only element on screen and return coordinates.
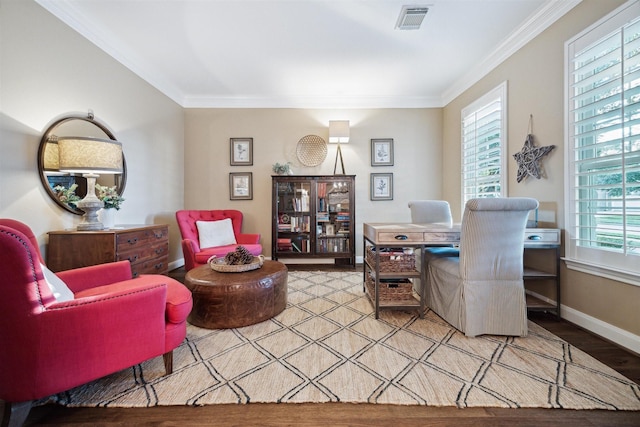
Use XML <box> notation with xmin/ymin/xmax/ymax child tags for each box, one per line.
<box><xmin>441</xmin><ymin>0</ymin><xmax>582</xmax><ymax>107</ymax></box>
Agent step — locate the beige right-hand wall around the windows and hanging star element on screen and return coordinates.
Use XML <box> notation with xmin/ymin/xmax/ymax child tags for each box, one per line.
<box><xmin>443</xmin><ymin>0</ymin><xmax>640</xmax><ymax>342</ymax></box>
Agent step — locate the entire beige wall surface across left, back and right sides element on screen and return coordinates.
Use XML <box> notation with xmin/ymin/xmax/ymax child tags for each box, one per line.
<box><xmin>0</xmin><ymin>0</ymin><xmax>640</xmax><ymax>348</ymax></box>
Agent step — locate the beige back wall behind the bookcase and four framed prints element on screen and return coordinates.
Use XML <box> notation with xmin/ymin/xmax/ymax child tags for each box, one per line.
<box><xmin>185</xmin><ymin>109</ymin><xmax>442</xmax><ymax>256</ymax></box>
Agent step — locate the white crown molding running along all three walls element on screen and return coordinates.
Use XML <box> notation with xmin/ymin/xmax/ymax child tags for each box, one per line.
<box><xmin>35</xmin><ymin>0</ymin><xmax>582</xmax><ymax>108</ymax></box>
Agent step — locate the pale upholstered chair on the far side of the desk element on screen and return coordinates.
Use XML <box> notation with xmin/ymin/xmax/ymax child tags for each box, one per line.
<box><xmin>409</xmin><ymin>200</ymin><xmax>457</xmax><ymax>298</ymax></box>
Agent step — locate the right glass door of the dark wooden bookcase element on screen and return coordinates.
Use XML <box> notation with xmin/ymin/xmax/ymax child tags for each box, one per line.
<box><xmin>315</xmin><ymin>179</ymin><xmax>352</xmax><ymax>254</ymax></box>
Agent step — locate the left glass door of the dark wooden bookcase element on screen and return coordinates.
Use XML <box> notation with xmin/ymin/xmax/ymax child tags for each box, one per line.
<box><xmin>276</xmin><ymin>181</ymin><xmax>311</xmax><ymax>256</ymax></box>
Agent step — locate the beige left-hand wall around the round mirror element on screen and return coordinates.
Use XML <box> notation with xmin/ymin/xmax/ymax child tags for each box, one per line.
<box><xmin>0</xmin><ymin>0</ymin><xmax>184</xmax><ymax>260</ymax></box>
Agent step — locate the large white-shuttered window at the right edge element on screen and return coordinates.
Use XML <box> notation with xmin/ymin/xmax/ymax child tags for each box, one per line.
<box><xmin>565</xmin><ymin>1</ymin><xmax>640</xmax><ymax>284</ymax></box>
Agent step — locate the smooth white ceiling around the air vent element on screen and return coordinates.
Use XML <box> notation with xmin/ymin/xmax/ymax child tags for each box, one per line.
<box><xmin>36</xmin><ymin>0</ymin><xmax>581</xmax><ymax>108</ymax></box>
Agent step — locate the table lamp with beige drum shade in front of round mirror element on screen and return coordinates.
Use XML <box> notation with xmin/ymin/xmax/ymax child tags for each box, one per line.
<box><xmin>58</xmin><ymin>136</ymin><xmax>123</xmax><ymax>231</ymax></box>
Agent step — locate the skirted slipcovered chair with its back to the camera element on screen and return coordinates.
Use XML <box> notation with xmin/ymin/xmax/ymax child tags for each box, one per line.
<box><xmin>427</xmin><ymin>197</ymin><xmax>538</xmax><ymax>337</ymax></box>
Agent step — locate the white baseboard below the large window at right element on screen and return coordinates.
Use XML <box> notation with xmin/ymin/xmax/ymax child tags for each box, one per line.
<box><xmin>527</xmin><ymin>291</ymin><xmax>640</xmax><ymax>355</ymax></box>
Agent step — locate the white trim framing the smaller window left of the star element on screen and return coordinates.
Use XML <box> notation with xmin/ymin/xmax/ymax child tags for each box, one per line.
<box><xmin>460</xmin><ymin>81</ymin><xmax>509</xmax><ymax>207</ymax></box>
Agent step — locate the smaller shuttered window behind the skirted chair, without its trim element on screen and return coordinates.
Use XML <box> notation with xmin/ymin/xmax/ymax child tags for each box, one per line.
<box><xmin>461</xmin><ymin>82</ymin><xmax>507</xmax><ymax>206</ymax></box>
